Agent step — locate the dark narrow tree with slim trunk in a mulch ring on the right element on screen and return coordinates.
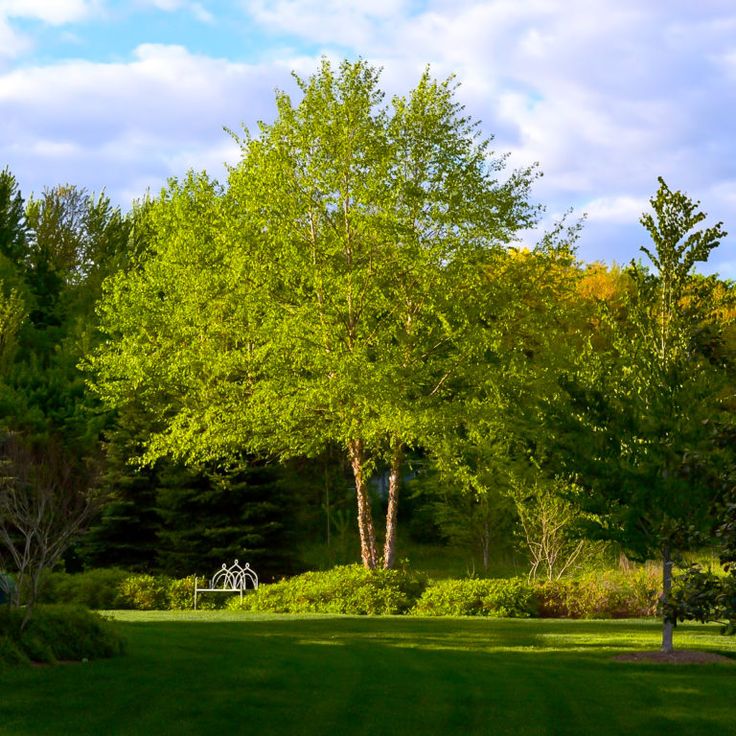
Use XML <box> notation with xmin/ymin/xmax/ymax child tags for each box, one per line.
<box><xmin>561</xmin><ymin>178</ymin><xmax>727</xmax><ymax>652</ymax></box>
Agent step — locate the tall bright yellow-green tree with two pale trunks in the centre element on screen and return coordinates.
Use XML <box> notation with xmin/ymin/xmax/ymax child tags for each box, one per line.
<box><xmin>92</xmin><ymin>61</ymin><xmax>535</xmax><ymax>568</ymax></box>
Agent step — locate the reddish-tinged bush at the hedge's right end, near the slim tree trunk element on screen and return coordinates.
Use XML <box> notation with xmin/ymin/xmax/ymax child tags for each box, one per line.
<box><xmin>537</xmin><ymin>567</ymin><xmax>659</xmax><ymax>618</ymax></box>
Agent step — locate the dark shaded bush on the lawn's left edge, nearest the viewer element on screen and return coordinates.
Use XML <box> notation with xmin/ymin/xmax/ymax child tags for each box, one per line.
<box><xmin>0</xmin><ymin>605</ymin><xmax>125</xmax><ymax>665</ymax></box>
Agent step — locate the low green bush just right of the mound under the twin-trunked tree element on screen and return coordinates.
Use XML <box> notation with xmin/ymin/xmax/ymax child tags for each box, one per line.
<box><xmin>412</xmin><ymin>578</ymin><xmax>537</xmax><ymax>618</ymax></box>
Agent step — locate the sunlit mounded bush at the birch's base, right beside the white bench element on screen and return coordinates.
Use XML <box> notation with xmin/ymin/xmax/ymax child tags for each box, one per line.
<box><xmin>228</xmin><ymin>565</ymin><xmax>426</xmax><ymax>615</ymax></box>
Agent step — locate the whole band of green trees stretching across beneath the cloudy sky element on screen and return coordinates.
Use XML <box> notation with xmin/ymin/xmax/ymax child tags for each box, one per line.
<box><xmin>0</xmin><ymin>61</ymin><xmax>734</xmax><ymax>648</ymax></box>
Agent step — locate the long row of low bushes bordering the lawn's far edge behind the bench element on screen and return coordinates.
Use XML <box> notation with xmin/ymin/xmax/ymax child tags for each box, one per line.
<box><xmin>36</xmin><ymin>565</ymin><xmax>659</xmax><ymax>618</ymax></box>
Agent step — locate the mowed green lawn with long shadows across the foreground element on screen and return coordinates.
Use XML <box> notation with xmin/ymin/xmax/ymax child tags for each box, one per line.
<box><xmin>0</xmin><ymin>611</ymin><xmax>736</xmax><ymax>736</ymax></box>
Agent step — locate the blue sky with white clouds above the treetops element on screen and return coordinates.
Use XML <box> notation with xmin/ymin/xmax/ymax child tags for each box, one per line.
<box><xmin>0</xmin><ymin>0</ymin><xmax>736</xmax><ymax>279</ymax></box>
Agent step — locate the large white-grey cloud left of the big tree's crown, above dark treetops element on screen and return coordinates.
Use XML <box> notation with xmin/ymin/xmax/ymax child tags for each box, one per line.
<box><xmin>0</xmin><ymin>44</ymin><xmax>300</xmax><ymax>207</ymax></box>
